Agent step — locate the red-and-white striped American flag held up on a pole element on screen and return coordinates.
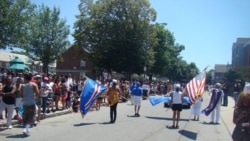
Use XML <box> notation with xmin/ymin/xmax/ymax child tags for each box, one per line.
<box><xmin>186</xmin><ymin>67</ymin><xmax>207</xmax><ymax>104</ymax></box>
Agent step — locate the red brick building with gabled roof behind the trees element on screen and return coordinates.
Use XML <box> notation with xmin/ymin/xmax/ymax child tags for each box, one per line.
<box><xmin>56</xmin><ymin>45</ymin><xmax>96</xmax><ymax>79</ymax></box>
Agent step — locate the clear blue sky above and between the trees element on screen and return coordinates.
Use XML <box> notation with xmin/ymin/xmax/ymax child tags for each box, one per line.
<box><xmin>31</xmin><ymin>0</ymin><xmax>250</xmax><ymax>70</ymax></box>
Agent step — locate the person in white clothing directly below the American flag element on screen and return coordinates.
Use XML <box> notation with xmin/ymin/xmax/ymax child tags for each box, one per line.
<box><xmin>191</xmin><ymin>95</ymin><xmax>203</xmax><ymax>121</ymax></box>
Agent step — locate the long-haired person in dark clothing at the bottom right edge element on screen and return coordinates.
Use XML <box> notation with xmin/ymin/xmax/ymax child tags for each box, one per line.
<box><xmin>232</xmin><ymin>92</ymin><xmax>250</xmax><ymax>141</ymax></box>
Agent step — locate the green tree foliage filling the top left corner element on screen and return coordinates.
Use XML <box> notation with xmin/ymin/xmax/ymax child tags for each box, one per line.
<box><xmin>0</xmin><ymin>0</ymin><xmax>35</xmax><ymax>49</ymax></box>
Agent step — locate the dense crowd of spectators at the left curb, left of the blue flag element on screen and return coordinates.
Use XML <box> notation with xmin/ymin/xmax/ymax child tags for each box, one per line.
<box><xmin>0</xmin><ymin>68</ymin><xmax>86</xmax><ymax>135</ymax></box>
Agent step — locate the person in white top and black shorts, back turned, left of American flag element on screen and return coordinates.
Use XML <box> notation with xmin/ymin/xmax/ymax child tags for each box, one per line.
<box><xmin>170</xmin><ymin>84</ymin><xmax>183</xmax><ymax>128</ymax></box>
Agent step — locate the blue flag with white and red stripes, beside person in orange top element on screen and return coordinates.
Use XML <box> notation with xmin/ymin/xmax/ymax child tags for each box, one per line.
<box><xmin>80</xmin><ymin>78</ymin><xmax>106</xmax><ymax>115</ymax></box>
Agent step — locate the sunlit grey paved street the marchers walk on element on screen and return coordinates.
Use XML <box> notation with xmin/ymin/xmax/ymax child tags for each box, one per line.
<box><xmin>0</xmin><ymin>92</ymin><xmax>234</xmax><ymax>141</ymax></box>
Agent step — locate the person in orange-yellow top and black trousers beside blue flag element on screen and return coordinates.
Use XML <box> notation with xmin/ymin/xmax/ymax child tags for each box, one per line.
<box><xmin>108</xmin><ymin>80</ymin><xmax>121</xmax><ymax>123</ymax></box>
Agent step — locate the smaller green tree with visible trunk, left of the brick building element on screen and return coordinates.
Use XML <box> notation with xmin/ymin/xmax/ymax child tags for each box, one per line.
<box><xmin>25</xmin><ymin>5</ymin><xmax>70</xmax><ymax>73</ymax></box>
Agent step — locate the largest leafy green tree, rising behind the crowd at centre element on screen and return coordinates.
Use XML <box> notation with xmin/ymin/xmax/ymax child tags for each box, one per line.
<box><xmin>74</xmin><ymin>0</ymin><xmax>156</xmax><ymax>78</ymax></box>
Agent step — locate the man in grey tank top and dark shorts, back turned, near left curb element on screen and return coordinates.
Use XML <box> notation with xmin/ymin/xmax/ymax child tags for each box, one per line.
<box><xmin>20</xmin><ymin>74</ymin><xmax>40</xmax><ymax>136</ymax></box>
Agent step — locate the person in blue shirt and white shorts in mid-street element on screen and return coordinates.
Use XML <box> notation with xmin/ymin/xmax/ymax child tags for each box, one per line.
<box><xmin>131</xmin><ymin>82</ymin><xmax>143</xmax><ymax>117</ymax></box>
